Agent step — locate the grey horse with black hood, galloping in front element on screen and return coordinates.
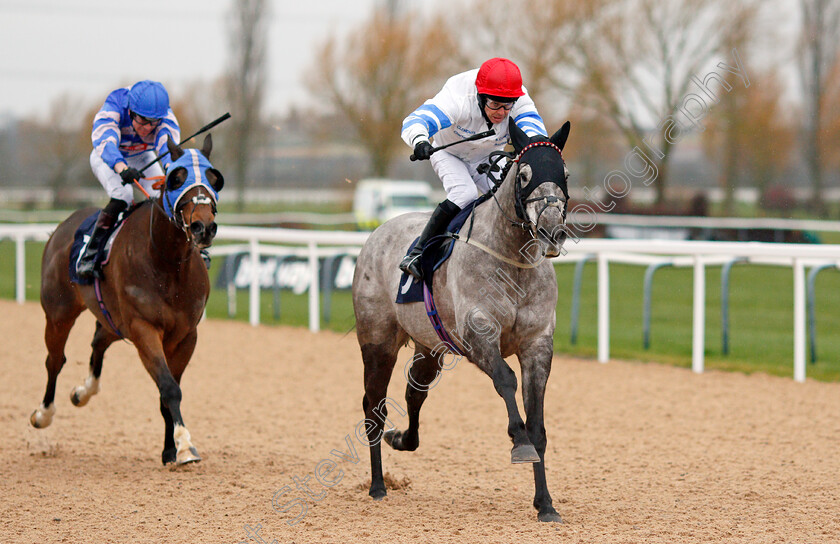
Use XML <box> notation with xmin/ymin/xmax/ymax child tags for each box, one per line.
<box><xmin>353</xmin><ymin>122</ymin><xmax>570</xmax><ymax>522</ymax></box>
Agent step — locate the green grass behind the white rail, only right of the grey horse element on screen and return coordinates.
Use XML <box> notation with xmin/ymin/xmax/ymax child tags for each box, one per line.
<box><xmin>555</xmin><ymin>264</ymin><xmax>840</xmax><ymax>381</ymax></box>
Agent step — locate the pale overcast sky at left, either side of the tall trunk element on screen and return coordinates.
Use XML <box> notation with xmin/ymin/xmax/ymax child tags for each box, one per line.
<box><xmin>0</xmin><ymin>0</ymin><xmax>384</xmax><ymax>121</ymax></box>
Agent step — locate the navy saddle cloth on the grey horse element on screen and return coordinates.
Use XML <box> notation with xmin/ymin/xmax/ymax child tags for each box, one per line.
<box><xmin>396</xmin><ymin>193</ymin><xmax>492</xmax><ymax>304</ymax></box>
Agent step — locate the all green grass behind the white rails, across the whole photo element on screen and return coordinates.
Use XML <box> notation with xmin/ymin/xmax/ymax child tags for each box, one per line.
<box><xmin>6</xmin><ymin>240</ymin><xmax>840</xmax><ymax>381</ymax></box>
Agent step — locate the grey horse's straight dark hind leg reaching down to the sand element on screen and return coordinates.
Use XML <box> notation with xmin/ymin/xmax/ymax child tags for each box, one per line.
<box><xmin>360</xmin><ymin>330</ymin><xmax>400</xmax><ymax>500</ymax></box>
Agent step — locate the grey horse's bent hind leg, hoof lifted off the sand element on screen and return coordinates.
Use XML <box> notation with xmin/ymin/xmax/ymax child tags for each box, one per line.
<box><xmin>383</xmin><ymin>344</ymin><xmax>445</xmax><ymax>451</ymax></box>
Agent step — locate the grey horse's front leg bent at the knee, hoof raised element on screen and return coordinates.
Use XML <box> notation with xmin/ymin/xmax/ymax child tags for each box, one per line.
<box><xmin>465</xmin><ymin>326</ymin><xmax>540</xmax><ymax>463</ymax></box>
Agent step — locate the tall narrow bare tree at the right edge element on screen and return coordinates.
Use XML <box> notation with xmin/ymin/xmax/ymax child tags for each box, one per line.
<box><xmin>799</xmin><ymin>0</ymin><xmax>840</xmax><ymax>214</ymax></box>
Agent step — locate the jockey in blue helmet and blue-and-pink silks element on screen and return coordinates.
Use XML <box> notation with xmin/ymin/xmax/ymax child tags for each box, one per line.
<box><xmin>77</xmin><ymin>80</ymin><xmax>181</xmax><ymax>278</ymax></box>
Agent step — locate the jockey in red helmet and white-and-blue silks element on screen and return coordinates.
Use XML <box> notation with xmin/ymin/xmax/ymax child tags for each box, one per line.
<box><xmin>400</xmin><ymin>58</ymin><xmax>547</xmax><ymax>279</ymax></box>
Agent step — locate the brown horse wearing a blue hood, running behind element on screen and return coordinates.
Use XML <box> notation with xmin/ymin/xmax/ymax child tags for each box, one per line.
<box><xmin>30</xmin><ymin>135</ymin><xmax>224</xmax><ymax>464</ymax></box>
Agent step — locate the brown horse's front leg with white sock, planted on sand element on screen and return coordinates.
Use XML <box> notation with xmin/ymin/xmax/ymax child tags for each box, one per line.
<box><xmin>131</xmin><ymin>321</ymin><xmax>201</xmax><ymax>465</ymax></box>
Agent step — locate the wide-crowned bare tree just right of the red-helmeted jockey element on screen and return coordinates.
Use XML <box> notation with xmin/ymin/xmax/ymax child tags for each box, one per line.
<box><xmin>465</xmin><ymin>0</ymin><xmax>757</xmax><ymax>204</ymax></box>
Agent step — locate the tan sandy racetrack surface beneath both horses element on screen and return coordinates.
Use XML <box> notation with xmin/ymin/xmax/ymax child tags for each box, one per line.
<box><xmin>0</xmin><ymin>301</ymin><xmax>840</xmax><ymax>544</ymax></box>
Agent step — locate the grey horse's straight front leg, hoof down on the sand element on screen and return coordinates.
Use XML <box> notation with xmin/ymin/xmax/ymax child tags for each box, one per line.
<box><xmin>517</xmin><ymin>336</ymin><xmax>563</xmax><ymax>522</ymax></box>
